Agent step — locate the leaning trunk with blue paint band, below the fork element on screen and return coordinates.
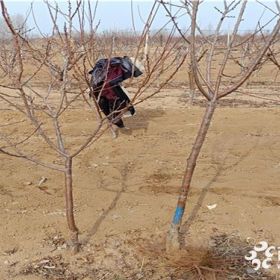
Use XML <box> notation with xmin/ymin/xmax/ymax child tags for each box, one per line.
<box><xmin>166</xmin><ymin>100</ymin><xmax>216</xmax><ymax>251</ymax></box>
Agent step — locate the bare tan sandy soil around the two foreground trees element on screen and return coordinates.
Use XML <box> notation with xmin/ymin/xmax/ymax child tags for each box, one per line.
<box><xmin>0</xmin><ymin>90</ymin><xmax>280</xmax><ymax>280</ymax></box>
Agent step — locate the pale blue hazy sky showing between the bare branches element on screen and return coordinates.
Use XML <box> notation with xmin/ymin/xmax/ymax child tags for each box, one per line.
<box><xmin>1</xmin><ymin>0</ymin><xmax>275</xmax><ymax>33</ymax></box>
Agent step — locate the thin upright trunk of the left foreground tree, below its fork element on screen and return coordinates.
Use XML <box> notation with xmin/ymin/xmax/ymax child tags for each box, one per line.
<box><xmin>65</xmin><ymin>157</ymin><xmax>79</xmax><ymax>253</ymax></box>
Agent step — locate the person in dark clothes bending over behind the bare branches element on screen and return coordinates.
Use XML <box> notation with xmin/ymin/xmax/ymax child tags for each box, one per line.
<box><xmin>89</xmin><ymin>56</ymin><xmax>143</xmax><ymax>131</ymax></box>
